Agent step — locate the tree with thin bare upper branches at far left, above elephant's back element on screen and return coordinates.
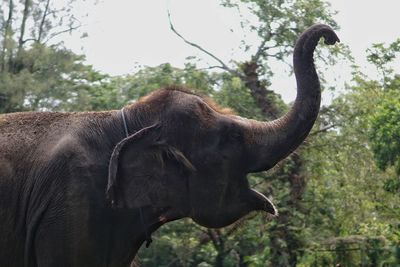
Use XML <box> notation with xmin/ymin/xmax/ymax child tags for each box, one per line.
<box><xmin>0</xmin><ymin>0</ymin><xmax>94</xmax><ymax>112</ymax></box>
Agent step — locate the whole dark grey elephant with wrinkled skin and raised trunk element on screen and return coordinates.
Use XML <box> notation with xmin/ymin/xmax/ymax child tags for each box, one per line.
<box><xmin>0</xmin><ymin>25</ymin><xmax>339</xmax><ymax>267</ymax></box>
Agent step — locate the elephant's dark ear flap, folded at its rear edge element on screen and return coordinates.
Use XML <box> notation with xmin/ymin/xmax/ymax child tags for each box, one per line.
<box><xmin>107</xmin><ymin>125</ymin><xmax>194</xmax><ymax>208</ymax></box>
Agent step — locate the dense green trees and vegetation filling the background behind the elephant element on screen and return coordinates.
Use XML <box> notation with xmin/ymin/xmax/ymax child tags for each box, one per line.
<box><xmin>0</xmin><ymin>0</ymin><xmax>400</xmax><ymax>267</ymax></box>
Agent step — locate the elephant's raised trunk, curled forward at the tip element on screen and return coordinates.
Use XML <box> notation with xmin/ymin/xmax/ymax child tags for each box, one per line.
<box><xmin>242</xmin><ymin>24</ymin><xmax>339</xmax><ymax>172</ymax></box>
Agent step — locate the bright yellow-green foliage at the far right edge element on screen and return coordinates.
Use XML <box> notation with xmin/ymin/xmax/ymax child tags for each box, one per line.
<box><xmin>368</xmin><ymin>39</ymin><xmax>400</xmax><ymax>193</ymax></box>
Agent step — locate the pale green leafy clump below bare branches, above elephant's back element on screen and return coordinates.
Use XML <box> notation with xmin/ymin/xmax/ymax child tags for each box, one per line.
<box><xmin>0</xmin><ymin>44</ymin><xmax>109</xmax><ymax>112</ymax></box>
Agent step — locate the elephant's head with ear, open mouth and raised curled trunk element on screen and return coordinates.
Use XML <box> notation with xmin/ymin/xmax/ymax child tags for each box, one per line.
<box><xmin>108</xmin><ymin>25</ymin><xmax>339</xmax><ymax>228</ymax></box>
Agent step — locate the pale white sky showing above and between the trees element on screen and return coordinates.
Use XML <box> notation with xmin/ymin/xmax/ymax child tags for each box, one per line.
<box><xmin>63</xmin><ymin>0</ymin><xmax>400</xmax><ymax>102</ymax></box>
